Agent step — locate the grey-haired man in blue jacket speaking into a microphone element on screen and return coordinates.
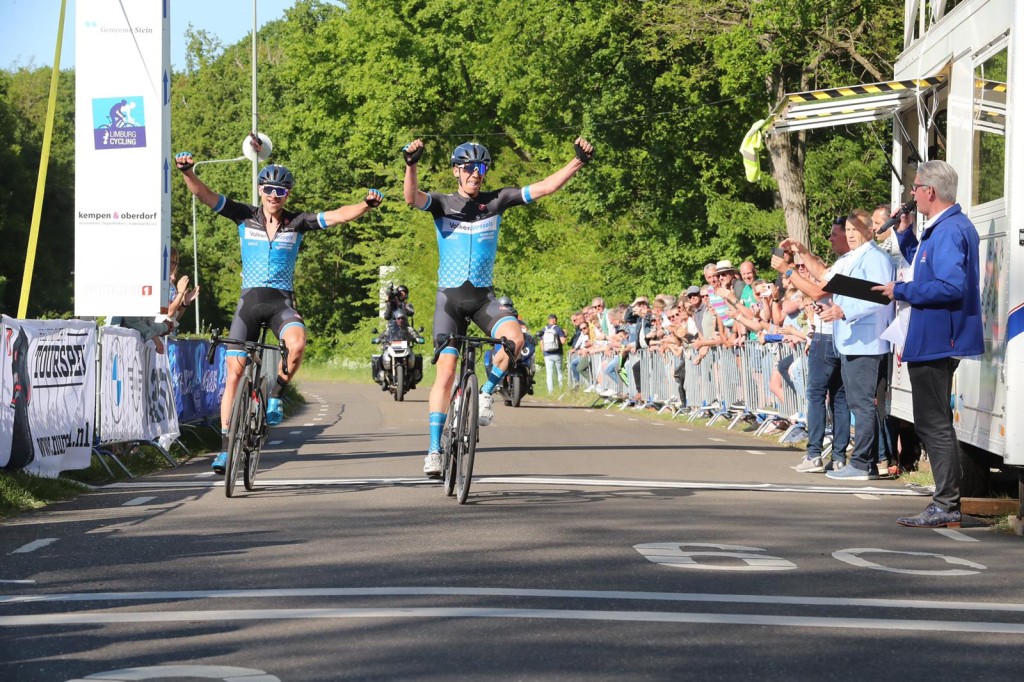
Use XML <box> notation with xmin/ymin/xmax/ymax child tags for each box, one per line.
<box><xmin>876</xmin><ymin>161</ymin><xmax>985</xmax><ymax>528</ymax></box>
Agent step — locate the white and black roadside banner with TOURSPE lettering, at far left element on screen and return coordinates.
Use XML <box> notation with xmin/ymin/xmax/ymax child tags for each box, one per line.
<box><xmin>0</xmin><ymin>315</ymin><xmax>96</xmax><ymax>477</ymax></box>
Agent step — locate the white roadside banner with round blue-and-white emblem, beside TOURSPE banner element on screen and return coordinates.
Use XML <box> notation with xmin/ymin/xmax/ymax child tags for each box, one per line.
<box><xmin>99</xmin><ymin>327</ymin><xmax>178</xmax><ymax>442</ymax></box>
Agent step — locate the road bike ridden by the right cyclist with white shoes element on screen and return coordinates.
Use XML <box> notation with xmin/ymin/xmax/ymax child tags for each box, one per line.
<box><xmin>430</xmin><ymin>334</ymin><xmax>515</xmax><ymax>505</ymax></box>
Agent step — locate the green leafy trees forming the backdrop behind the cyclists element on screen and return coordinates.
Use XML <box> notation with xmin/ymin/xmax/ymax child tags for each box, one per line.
<box><xmin>6</xmin><ymin>0</ymin><xmax>900</xmax><ymax>356</ymax></box>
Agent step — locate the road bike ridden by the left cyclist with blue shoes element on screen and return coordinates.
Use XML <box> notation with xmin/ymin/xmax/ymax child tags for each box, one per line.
<box><xmin>206</xmin><ymin>325</ymin><xmax>288</xmax><ymax>498</ymax></box>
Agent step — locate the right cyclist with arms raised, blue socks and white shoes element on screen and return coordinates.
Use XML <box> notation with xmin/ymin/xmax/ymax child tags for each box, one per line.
<box><xmin>402</xmin><ymin>137</ymin><xmax>594</xmax><ymax>477</ymax></box>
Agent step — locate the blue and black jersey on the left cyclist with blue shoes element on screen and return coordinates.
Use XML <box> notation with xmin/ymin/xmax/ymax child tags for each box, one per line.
<box><xmin>213</xmin><ymin>195</ymin><xmax>327</xmax><ymax>291</ymax></box>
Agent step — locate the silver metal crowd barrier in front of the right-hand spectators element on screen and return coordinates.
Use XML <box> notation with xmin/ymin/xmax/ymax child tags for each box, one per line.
<box><xmin>567</xmin><ymin>341</ymin><xmax>807</xmax><ymax>440</ymax></box>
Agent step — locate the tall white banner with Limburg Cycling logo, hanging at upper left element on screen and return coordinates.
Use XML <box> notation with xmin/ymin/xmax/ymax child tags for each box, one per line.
<box><xmin>75</xmin><ymin>0</ymin><xmax>174</xmax><ymax>316</ymax></box>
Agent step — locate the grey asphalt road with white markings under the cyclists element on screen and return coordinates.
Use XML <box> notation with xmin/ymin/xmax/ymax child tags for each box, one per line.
<box><xmin>0</xmin><ymin>383</ymin><xmax>1024</xmax><ymax>682</ymax></box>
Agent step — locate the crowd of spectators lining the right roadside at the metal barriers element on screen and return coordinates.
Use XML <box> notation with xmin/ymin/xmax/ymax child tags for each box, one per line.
<box><xmin>549</xmin><ymin>199</ymin><xmax>919</xmax><ymax>480</ymax></box>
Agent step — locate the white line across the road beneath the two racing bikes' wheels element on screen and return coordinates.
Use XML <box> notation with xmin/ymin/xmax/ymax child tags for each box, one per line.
<box><xmin>102</xmin><ymin>476</ymin><xmax>931</xmax><ymax>498</ymax></box>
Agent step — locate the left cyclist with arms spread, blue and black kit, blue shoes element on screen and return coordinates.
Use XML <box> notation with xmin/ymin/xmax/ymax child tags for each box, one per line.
<box><xmin>176</xmin><ymin>152</ymin><xmax>383</xmax><ymax>473</ymax></box>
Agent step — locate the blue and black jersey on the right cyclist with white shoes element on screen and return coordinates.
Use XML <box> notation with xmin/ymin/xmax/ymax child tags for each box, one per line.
<box><xmin>423</xmin><ymin>186</ymin><xmax>531</xmax><ymax>289</ymax></box>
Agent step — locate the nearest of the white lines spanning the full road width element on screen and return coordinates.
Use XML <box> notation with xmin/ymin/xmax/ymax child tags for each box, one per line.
<box><xmin>8</xmin><ymin>606</ymin><xmax>1024</xmax><ymax>635</ymax></box>
